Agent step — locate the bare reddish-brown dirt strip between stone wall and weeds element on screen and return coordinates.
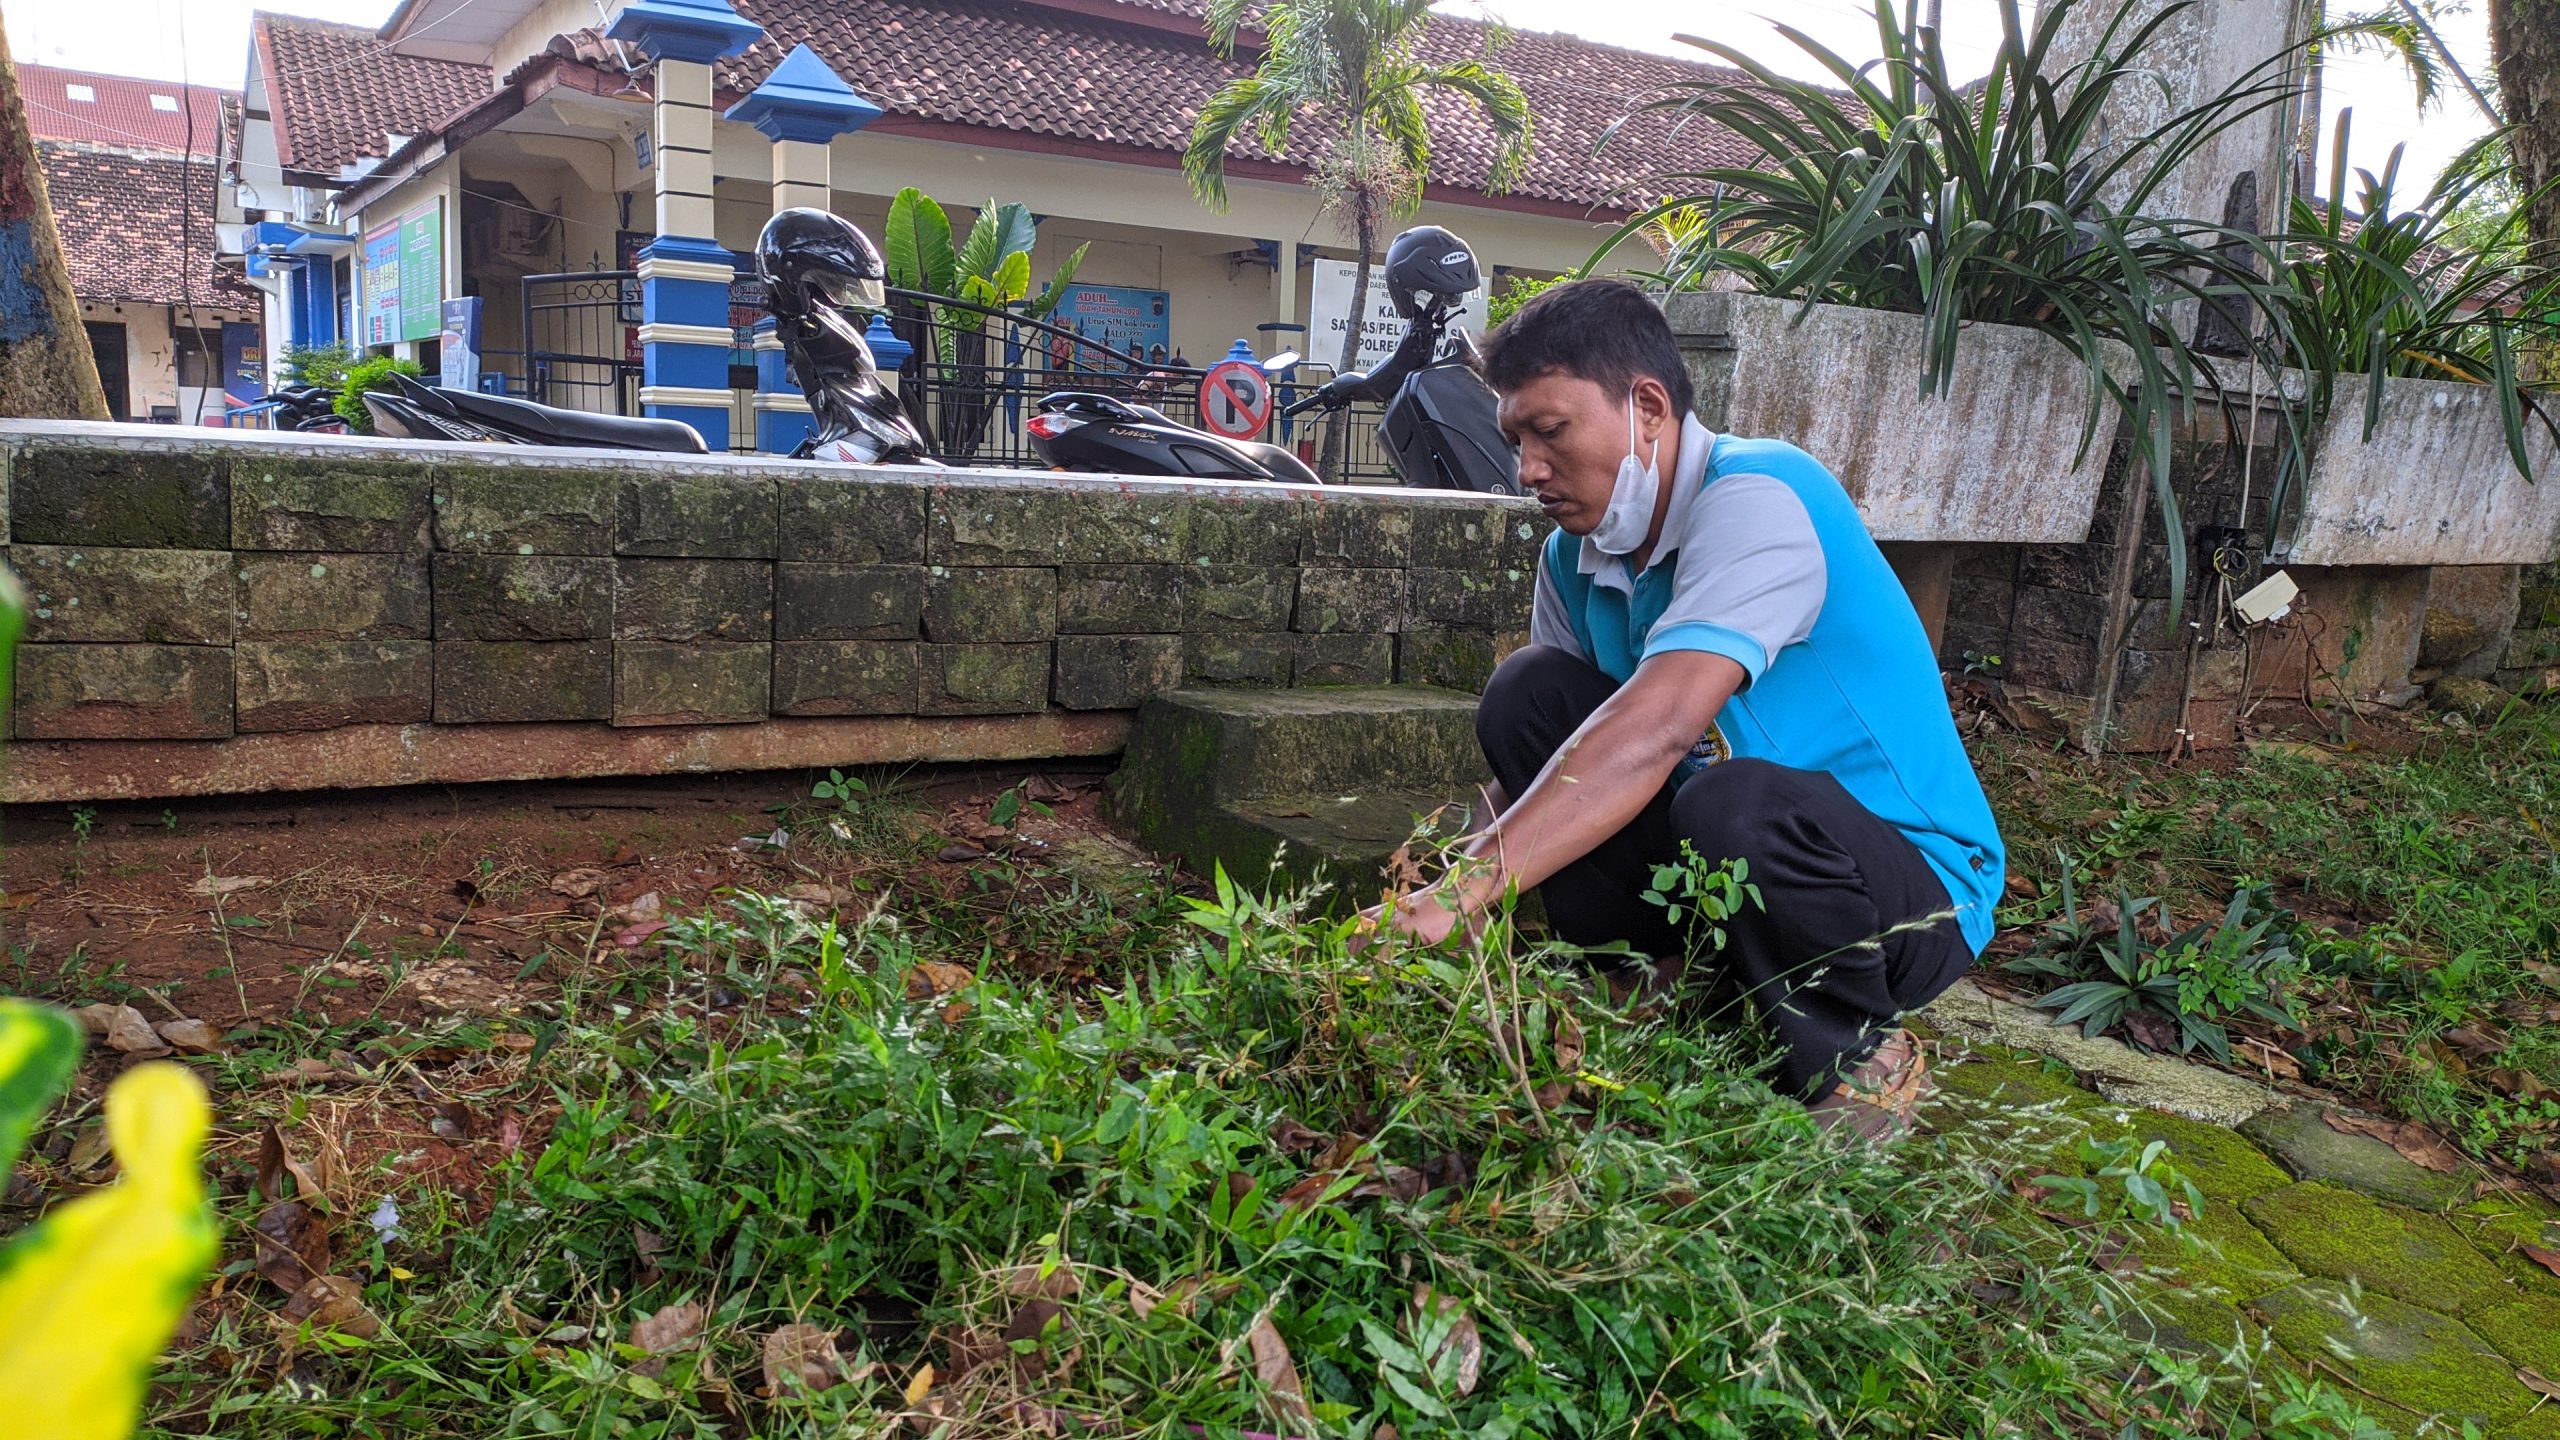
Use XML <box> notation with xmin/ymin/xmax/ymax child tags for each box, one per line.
<box><xmin>0</xmin><ymin>764</ymin><xmax>1144</xmax><ymax>1050</ymax></box>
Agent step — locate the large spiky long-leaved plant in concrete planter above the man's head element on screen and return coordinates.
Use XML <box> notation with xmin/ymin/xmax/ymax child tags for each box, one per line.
<box><xmin>1585</xmin><ymin>0</ymin><xmax>2304</xmax><ymax>614</ymax></box>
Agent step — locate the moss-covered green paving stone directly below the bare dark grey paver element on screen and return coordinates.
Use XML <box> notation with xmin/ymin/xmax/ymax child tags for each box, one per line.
<box><xmin>2243</xmin><ymin>1181</ymin><xmax>2514</xmax><ymax>1314</ymax></box>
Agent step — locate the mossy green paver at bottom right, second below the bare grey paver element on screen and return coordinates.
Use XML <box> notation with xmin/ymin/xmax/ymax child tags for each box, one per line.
<box><xmin>2255</xmin><ymin>1281</ymin><xmax>2534</xmax><ymax>1435</ymax></box>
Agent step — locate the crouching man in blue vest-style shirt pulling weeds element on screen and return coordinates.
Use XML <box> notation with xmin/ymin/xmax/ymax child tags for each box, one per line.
<box><xmin>1370</xmin><ymin>279</ymin><xmax>2004</xmax><ymax>1135</ymax></box>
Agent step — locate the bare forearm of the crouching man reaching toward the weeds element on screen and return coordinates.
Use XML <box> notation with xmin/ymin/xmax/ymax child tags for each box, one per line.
<box><xmin>1454</xmin><ymin>651</ymin><xmax>1748</xmax><ymax>912</ymax></box>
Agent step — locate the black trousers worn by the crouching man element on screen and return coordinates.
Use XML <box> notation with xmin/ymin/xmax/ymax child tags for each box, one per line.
<box><xmin>1475</xmin><ymin>646</ymin><xmax>1974</xmax><ymax>1099</ymax></box>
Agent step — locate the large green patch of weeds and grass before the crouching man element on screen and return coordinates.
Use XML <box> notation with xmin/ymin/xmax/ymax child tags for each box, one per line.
<box><xmin>99</xmin><ymin>855</ymin><xmax>2396</xmax><ymax>1440</ymax></box>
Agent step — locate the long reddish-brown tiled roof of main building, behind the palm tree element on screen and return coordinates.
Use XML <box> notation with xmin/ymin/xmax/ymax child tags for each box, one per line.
<box><xmin>670</xmin><ymin>0</ymin><xmax>1754</xmax><ymax>210</ymax></box>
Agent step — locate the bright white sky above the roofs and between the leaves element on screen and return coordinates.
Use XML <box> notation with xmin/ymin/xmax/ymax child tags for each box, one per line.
<box><xmin>0</xmin><ymin>0</ymin><xmax>2496</xmax><ymax>204</ymax></box>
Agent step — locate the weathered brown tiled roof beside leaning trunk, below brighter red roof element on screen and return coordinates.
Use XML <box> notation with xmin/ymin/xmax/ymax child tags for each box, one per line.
<box><xmin>36</xmin><ymin>141</ymin><xmax>261</xmax><ymax>310</ymax></box>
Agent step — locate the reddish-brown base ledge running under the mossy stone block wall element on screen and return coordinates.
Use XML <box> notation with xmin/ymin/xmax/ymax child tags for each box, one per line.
<box><xmin>0</xmin><ymin>712</ymin><xmax>1132</xmax><ymax>805</ymax></box>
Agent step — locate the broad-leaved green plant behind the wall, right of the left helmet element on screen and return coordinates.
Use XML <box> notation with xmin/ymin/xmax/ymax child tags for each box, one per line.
<box><xmin>883</xmin><ymin>187</ymin><xmax>1093</xmax><ymax>459</ymax></box>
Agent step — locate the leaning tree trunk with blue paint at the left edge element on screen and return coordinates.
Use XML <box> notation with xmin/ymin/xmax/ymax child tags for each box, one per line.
<box><xmin>0</xmin><ymin>23</ymin><xmax>108</xmax><ymax>420</ymax></box>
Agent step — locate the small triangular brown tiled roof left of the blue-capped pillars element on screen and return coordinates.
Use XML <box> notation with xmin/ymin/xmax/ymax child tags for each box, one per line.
<box><xmin>253</xmin><ymin>10</ymin><xmax>489</xmax><ymax>174</ymax></box>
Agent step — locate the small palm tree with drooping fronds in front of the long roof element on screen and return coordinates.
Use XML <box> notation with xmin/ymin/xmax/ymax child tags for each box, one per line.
<box><xmin>1183</xmin><ymin>0</ymin><xmax>1531</xmax><ymax>474</ymax></box>
